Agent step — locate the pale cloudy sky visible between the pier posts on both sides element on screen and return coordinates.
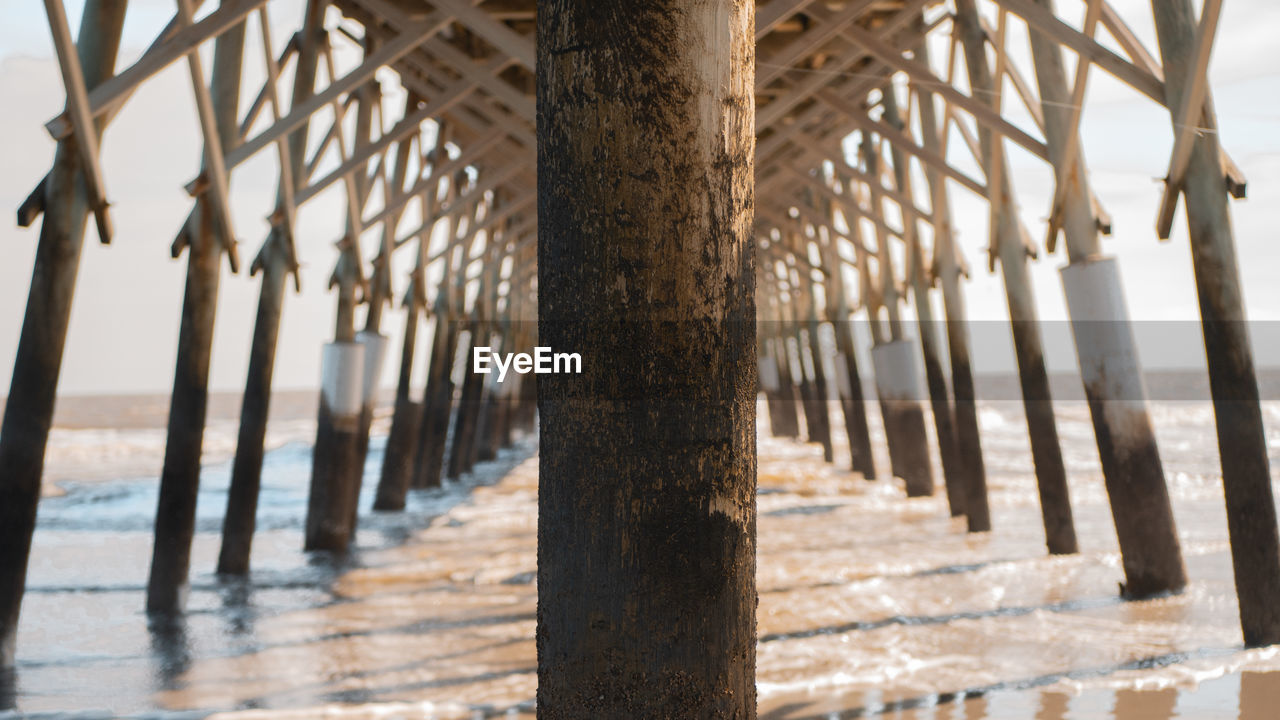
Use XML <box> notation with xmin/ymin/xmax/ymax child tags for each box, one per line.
<box><xmin>0</xmin><ymin>0</ymin><xmax>1280</xmax><ymax>395</ymax></box>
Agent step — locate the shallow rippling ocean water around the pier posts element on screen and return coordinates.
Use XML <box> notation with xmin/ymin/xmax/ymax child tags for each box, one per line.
<box><xmin>0</xmin><ymin>379</ymin><xmax>1280</xmax><ymax>720</ymax></box>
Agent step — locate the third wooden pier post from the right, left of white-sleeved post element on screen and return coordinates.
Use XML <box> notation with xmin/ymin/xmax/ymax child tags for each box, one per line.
<box><xmin>956</xmin><ymin>0</ymin><xmax>1068</xmax><ymax>537</ymax></box>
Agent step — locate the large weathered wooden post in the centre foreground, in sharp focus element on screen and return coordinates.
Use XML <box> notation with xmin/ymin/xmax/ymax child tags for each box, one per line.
<box><xmin>526</xmin><ymin>0</ymin><xmax>756</xmax><ymax>720</ymax></box>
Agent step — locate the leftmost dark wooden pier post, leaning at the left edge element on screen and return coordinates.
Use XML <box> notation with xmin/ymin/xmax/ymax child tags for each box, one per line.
<box><xmin>0</xmin><ymin>0</ymin><xmax>128</xmax><ymax>673</ymax></box>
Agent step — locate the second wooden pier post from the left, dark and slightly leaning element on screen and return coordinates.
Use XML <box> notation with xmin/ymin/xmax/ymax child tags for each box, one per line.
<box><xmin>147</xmin><ymin>19</ymin><xmax>244</xmax><ymax>614</ymax></box>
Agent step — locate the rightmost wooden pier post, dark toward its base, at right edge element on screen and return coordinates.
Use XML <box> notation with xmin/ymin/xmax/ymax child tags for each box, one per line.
<box><xmin>1152</xmin><ymin>0</ymin><xmax>1280</xmax><ymax>638</ymax></box>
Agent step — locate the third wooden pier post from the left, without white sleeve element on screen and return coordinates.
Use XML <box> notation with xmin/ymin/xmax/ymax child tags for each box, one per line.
<box><xmin>218</xmin><ymin>0</ymin><xmax>324</xmax><ymax>575</ymax></box>
